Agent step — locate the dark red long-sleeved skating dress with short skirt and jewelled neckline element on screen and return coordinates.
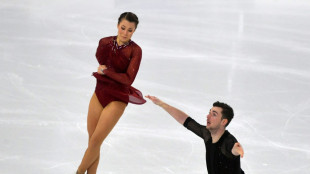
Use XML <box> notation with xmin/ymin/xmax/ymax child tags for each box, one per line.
<box><xmin>93</xmin><ymin>36</ymin><xmax>146</xmax><ymax>107</ymax></box>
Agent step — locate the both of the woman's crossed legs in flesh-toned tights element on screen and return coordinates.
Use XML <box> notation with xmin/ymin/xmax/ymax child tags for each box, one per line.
<box><xmin>77</xmin><ymin>93</ymin><xmax>127</xmax><ymax>174</ymax></box>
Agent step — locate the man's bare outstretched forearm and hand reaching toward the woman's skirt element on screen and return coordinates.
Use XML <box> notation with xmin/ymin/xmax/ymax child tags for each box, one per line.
<box><xmin>145</xmin><ymin>95</ymin><xmax>188</xmax><ymax>125</ymax></box>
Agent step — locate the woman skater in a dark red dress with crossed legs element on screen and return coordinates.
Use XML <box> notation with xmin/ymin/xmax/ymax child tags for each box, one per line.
<box><xmin>76</xmin><ymin>12</ymin><xmax>146</xmax><ymax>174</ymax></box>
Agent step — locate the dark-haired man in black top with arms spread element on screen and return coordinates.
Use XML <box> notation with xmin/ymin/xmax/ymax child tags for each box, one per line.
<box><xmin>146</xmin><ymin>95</ymin><xmax>244</xmax><ymax>174</ymax></box>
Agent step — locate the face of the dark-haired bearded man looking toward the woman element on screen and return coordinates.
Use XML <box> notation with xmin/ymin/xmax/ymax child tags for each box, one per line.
<box><xmin>206</xmin><ymin>107</ymin><xmax>226</xmax><ymax>131</ymax></box>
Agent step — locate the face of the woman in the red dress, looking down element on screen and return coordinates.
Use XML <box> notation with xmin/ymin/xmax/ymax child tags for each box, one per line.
<box><xmin>117</xmin><ymin>19</ymin><xmax>136</xmax><ymax>45</ymax></box>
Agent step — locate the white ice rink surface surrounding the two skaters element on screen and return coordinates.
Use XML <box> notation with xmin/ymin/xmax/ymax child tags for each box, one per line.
<box><xmin>0</xmin><ymin>0</ymin><xmax>310</xmax><ymax>174</ymax></box>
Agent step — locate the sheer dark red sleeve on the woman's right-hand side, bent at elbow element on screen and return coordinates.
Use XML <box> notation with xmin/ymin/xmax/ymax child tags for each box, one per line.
<box><xmin>103</xmin><ymin>44</ymin><xmax>142</xmax><ymax>85</ymax></box>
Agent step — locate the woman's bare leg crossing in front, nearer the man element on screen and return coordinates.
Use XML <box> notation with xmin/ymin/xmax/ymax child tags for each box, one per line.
<box><xmin>78</xmin><ymin>99</ymin><xmax>127</xmax><ymax>174</ymax></box>
